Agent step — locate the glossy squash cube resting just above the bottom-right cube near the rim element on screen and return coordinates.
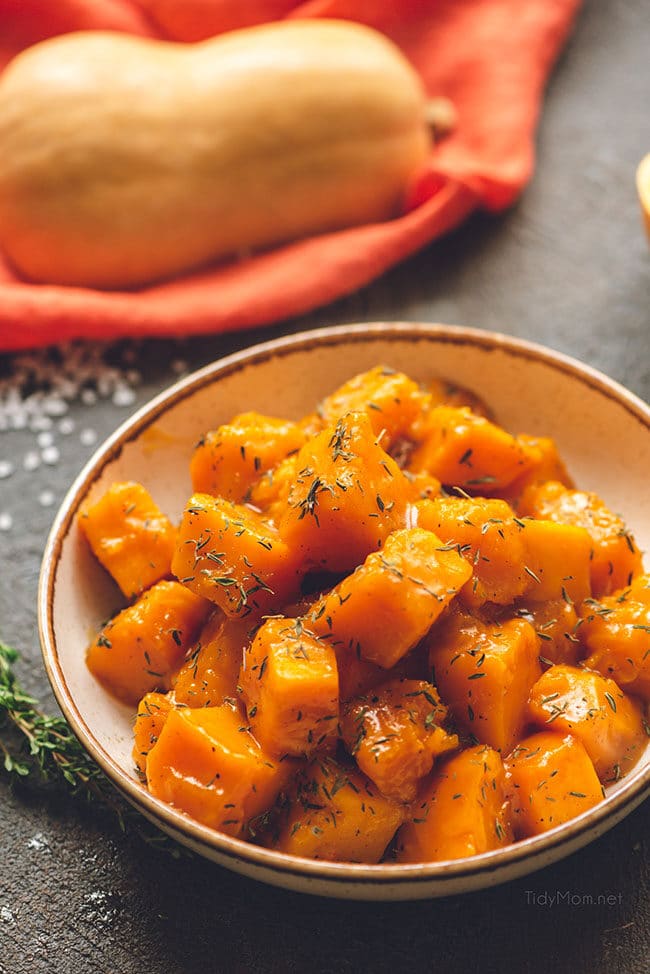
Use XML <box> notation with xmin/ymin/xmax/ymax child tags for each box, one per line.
<box><xmin>528</xmin><ymin>664</ymin><xmax>648</xmax><ymax>782</ymax></box>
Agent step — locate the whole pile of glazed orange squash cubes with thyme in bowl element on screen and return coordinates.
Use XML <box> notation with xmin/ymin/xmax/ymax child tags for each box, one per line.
<box><xmin>79</xmin><ymin>366</ymin><xmax>650</xmax><ymax>864</ymax></box>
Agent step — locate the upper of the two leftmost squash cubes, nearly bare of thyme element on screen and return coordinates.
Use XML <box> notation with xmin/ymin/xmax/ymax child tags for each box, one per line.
<box><xmin>78</xmin><ymin>481</ymin><xmax>176</xmax><ymax>599</ymax></box>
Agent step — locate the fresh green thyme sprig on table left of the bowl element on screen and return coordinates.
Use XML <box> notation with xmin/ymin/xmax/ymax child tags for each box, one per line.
<box><xmin>0</xmin><ymin>640</ymin><xmax>190</xmax><ymax>858</ymax></box>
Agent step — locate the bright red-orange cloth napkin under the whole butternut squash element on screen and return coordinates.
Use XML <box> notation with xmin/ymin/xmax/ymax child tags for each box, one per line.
<box><xmin>0</xmin><ymin>0</ymin><xmax>580</xmax><ymax>350</ymax></box>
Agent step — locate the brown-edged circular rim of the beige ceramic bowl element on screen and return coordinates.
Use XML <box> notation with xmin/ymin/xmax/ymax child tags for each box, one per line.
<box><xmin>38</xmin><ymin>321</ymin><xmax>650</xmax><ymax>886</ymax></box>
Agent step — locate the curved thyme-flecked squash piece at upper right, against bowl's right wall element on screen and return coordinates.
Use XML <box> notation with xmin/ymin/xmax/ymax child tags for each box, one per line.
<box><xmin>519</xmin><ymin>481</ymin><xmax>643</xmax><ymax>598</ymax></box>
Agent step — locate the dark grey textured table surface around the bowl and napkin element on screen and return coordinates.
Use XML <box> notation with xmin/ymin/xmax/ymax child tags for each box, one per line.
<box><xmin>0</xmin><ymin>0</ymin><xmax>650</xmax><ymax>974</ymax></box>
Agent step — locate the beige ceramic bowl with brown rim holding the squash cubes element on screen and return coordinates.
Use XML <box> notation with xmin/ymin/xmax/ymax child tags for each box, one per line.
<box><xmin>39</xmin><ymin>324</ymin><xmax>650</xmax><ymax>899</ymax></box>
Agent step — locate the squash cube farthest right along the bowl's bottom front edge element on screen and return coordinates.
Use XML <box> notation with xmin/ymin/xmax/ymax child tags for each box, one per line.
<box><xmin>504</xmin><ymin>731</ymin><xmax>603</xmax><ymax>839</ymax></box>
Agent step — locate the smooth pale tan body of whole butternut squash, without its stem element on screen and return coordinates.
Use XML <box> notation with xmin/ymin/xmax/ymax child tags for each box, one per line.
<box><xmin>0</xmin><ymin>21</ymin><xmax>430</xmax><ymax>288</ymax></box>
